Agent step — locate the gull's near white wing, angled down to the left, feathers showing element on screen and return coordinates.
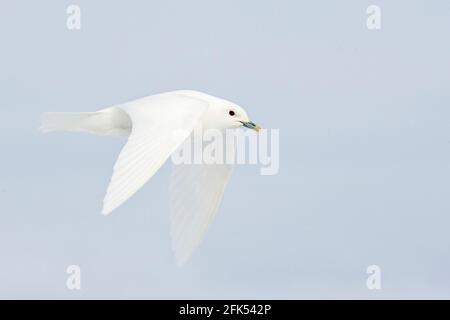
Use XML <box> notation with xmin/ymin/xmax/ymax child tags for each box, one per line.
<box><xmin>102</xmin><ymin>93</ymin><xmax>208</xmax><ymax>215</ymax></box>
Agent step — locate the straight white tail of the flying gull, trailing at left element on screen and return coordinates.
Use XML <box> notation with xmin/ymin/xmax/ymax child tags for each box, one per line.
<box><xmin>40</xmin><ymin>107</ymin><xmax>131</xmax><ymax>135</ymax></box>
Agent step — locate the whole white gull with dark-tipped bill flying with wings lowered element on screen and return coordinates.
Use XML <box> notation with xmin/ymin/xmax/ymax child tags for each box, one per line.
<box><xmin>41</xmin><ymin>90</ymin><xmax>260</xmax><ymax>266</ymax></box>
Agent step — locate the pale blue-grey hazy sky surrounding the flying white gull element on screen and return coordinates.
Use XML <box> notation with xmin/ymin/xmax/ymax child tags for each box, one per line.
<box><xmin>0</xmin><ymin>0</ymin><xmax>450</xmax><ymax>299</ymax></box>
